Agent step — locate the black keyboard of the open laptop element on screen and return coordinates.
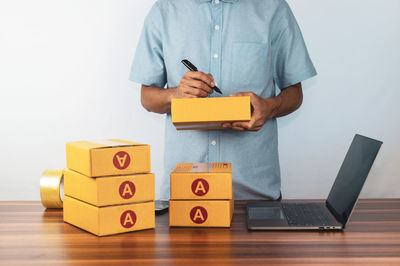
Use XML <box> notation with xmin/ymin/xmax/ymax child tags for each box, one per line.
<box><xmin>282</xmin><ymin>203</ymin><xmax>337</xmax><ymax>226</ymax></box>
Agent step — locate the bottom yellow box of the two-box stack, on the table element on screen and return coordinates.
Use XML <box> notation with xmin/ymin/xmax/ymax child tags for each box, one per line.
<box><xmin>169</xmin><ymin>199</ymin><xmax>234</xmax><ymax>227</ymax></box>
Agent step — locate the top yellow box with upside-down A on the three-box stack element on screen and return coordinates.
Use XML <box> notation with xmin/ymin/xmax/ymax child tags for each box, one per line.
<box><xmin>66</xmin><ymin>139</ymin><xmax>150</xmax><ymax>177</ymax></box>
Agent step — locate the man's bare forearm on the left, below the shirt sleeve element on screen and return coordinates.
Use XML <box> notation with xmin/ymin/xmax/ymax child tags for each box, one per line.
<box><xmin>141</xmin><ymin>85</ymin><xmax>176</xmax><ymax>114</ymax></box>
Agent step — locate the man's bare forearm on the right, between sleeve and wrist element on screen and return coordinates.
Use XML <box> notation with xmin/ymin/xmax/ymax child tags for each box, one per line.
<box><xmin>264</xmin><ymin>83</ymin><xmax>303</xmax><ymax>117</ymax></box>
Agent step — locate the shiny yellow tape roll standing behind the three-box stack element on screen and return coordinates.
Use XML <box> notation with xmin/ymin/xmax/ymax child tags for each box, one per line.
<box><xmin>40</xmin><ymin>170</ymin><xmax>64</xmax><ymax>209</ymax></box>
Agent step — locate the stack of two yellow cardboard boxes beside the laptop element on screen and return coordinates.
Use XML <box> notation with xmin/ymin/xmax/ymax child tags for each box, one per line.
<box><xmin>169</xmin><ymin>163</ymin><xmax>234</xmax><ymax>227</ymax></box>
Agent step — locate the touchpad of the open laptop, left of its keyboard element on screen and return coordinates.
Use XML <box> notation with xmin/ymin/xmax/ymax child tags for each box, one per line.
<box><xmin>248</xmin><ymin>207</ymin><xmax>287</xmax><ymax>225</ymax></box>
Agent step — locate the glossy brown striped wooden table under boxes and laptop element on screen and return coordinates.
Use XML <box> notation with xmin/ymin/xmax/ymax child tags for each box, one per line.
<box><xmin>0</xmin><ymin>199</ymin><xmax>400</xmax><ymax>266</ymax></box>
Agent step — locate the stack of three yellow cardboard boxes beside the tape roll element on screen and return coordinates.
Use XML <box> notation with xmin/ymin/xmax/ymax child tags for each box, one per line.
<box><xmin>64</xmin><ymin>140</ymin><xmax>155</xmax><ymax>236</ymax></box>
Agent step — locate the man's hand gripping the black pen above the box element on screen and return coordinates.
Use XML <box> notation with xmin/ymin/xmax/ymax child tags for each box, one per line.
<box><xmin>171</xmin><ymin>71</ymin><xmax>215</xmax><ymax>98</ymax></box>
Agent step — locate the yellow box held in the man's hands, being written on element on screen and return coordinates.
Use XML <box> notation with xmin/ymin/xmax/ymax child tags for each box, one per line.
<box><xmin>171</xmin><ymin>96</ymin><xmax>251</xmax><ymax>130</ymax></box>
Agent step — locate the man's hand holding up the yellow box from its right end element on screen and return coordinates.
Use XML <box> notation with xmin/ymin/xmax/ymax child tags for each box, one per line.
<box><xmin>222</xmin><ymin>92</ymin><xmax>281</xmax><ymax>131</ymax></box>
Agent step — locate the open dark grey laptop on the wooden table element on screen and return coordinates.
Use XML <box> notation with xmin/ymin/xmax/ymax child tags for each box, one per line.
<box><xmin>246</xmin><ymin>135</ymin><xmax>382</xmax><ymax>230</ymax></box>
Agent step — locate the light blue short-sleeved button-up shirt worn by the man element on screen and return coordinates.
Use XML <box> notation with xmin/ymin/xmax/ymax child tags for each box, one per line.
<box><xmin>130</xmin><ymin>0</ymin><xmax>316</xmax><ymax>199</ymax></box>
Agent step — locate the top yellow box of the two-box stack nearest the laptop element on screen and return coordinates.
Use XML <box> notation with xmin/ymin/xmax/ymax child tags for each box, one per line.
<box><xmin>170</xmin><ymin>163</ymin><xmax>233</xmax><ymax>200</ymax></box>
